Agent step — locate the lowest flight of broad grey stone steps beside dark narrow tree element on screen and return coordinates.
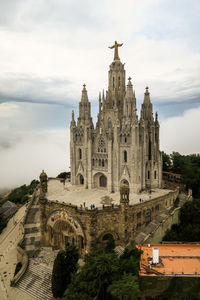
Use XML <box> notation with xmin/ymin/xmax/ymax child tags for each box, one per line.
<box><xmin>16</xmin><ymin>259</ymin><xmax>52</xmax><ymax>300</ymax></box>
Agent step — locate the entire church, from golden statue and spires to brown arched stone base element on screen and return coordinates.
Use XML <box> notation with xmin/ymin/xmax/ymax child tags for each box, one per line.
<box><xmin>35</xmin><ymin>42</ymin><xmax>173</xmax><ymax>256</ymax></box>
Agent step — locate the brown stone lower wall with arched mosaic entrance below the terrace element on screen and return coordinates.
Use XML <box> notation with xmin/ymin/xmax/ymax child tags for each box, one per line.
<box><xmin>40</xmin><ymin>190</ymin><xmax>178</xmax><ymax>254</ymax></box>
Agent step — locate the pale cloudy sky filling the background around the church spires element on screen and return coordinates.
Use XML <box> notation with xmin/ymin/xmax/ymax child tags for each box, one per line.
<box><xmin>0</xmin><ymin>0</ymin><xmax>200</xmax><ymax>187</ymax></box>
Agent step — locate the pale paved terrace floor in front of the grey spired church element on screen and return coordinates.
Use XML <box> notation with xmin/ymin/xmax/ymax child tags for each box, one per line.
<box><xmin>46</xmin><ymin>179</ymin><xmax>170</xmax><ymax>208</ymax></box>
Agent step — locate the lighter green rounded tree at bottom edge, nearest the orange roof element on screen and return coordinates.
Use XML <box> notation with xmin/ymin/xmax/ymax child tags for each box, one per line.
<box><xmin>107</xmin><ymin>273</ymin><xmax>140</xmax><ymax>300</ymax></box>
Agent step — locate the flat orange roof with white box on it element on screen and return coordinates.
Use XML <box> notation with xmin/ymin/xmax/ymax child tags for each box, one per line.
<box><xmin>137</xmin><ymin>244</ymin><xmax>200</xmax><ymax>277</ymax></box>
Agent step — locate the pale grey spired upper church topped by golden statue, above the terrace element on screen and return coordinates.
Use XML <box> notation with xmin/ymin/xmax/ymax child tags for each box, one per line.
<box><xmin>70</xmin><ymin>42</ymin><xmax>162</xmax><ymax>192</ymax></box>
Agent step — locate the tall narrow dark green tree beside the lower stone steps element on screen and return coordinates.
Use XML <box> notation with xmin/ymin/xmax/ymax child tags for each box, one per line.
<box><xmin>51</xmin><ymin>245</ymin><xmax>79</xmax><ymax>298</ymax></box>
